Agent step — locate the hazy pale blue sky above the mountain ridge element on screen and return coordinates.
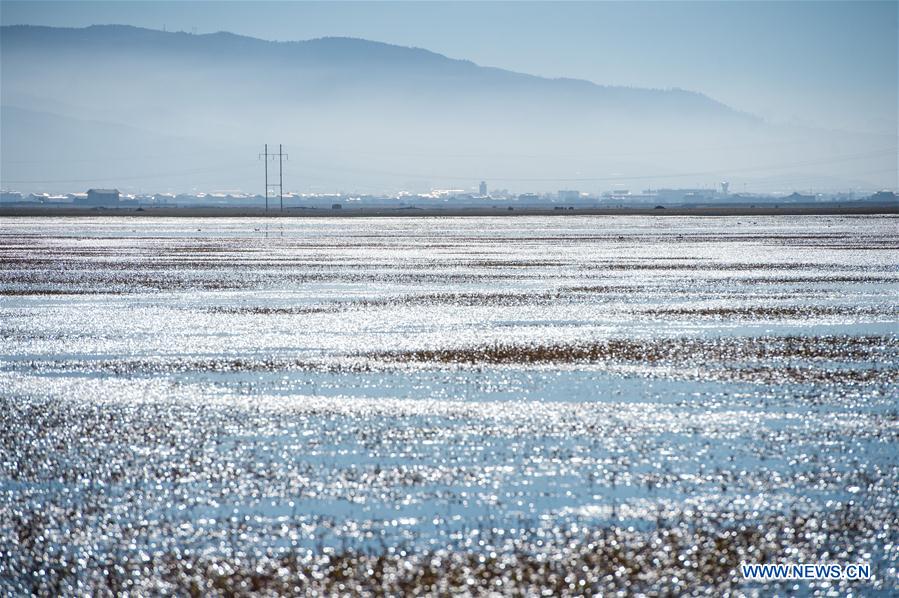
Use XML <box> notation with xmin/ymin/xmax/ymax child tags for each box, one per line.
<box><xmin>0</xmin><ymin>0</ymin><xmax>899</xmax><ymax>133</ymax></box>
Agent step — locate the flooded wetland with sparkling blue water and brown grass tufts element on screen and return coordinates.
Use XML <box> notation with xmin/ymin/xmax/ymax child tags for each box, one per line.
<box><xmin>0</xmin><ymin>216</ymin><xmax>899</xmax><ymax>595</ymax></box>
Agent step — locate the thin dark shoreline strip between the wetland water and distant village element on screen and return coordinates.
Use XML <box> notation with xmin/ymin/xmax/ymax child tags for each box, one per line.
<box><xmin>0</xmin><ymin>204</ymin><xmax>899</xmax><ymax>218</ymax></box>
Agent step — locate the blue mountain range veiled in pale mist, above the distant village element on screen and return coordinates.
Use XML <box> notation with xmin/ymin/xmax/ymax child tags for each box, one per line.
<box><xmin>0</xmin><ymin>26</ymin><xmax>896</xmax><ymax>192</ymax></box>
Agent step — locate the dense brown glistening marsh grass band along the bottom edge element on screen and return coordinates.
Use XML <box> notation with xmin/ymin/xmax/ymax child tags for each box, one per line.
<box><xmin>6</xmin><ymin>508</ymin><xmax>899</xmax><ymax>596</ymax></box>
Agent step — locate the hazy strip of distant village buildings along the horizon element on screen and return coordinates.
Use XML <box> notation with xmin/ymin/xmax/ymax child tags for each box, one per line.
<box><xmin>0</xmin><ymin>181</ymin><xmax>897</xmax><ymax>211</ymax></box>
